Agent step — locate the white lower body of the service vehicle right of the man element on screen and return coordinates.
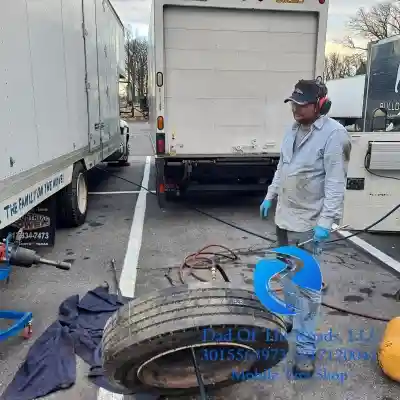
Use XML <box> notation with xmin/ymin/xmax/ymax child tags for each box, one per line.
<box><xmin>341</xmin><ymin>132</ymin><xmax>400</xmax><ymax>232</ymax></box>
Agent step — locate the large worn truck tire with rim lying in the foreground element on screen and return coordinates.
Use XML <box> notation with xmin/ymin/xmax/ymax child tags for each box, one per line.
<box><xmin>102</xmin><ymin>283</ymin><xmax>288</xmax><ymax>396</ymax></box>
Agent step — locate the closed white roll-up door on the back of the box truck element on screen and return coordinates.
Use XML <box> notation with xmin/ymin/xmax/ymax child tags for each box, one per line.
<box><xmin>164</xmin><ymin>6</ymin><xmax>318</xmax><ymax>155</ymax></box>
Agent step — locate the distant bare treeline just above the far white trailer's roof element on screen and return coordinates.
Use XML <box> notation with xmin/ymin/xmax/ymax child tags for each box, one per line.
<box><xmin>324</xmin><ymin>53</ymin><xmax>366</xmax><ymax>81</ymax></box>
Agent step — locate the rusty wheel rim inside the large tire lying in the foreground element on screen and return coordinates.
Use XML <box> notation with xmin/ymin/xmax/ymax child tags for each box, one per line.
<box><xmin>137</xmin><ymin>342</ymin><xmax>257</xmax><ymax>389</ymax></box>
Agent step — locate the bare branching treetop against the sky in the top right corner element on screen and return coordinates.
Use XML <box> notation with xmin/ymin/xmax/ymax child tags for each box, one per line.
<box><xmin>343</xmin><ymin>1</ymin><xmax>400</xmax><ymax>51</ymax></box>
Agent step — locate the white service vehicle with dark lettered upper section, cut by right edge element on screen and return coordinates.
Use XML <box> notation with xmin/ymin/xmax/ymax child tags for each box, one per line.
<box><xmin>342</xmin><ymin>35</ymin><xmax>400</xmax><ymax>232</ymax></box>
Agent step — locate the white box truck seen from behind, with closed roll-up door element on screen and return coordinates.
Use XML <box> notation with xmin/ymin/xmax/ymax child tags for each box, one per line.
<box><xmin>148</xmin><ymin>0</ymin><xmax>328</xmax><ymax>206</ymax></box>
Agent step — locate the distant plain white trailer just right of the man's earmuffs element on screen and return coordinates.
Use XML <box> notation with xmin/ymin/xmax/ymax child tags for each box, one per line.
<box><xmin>326</xmin><ymin>75</ymin><xmax>365</xmax><ymax>131</ymax></box>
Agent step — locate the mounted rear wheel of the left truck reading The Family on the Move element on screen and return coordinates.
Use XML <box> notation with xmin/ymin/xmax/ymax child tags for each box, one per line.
<box><xmin>57</xmin><ymin>162</ymin><xmax>88</xmax><ymax>228</ymax></box>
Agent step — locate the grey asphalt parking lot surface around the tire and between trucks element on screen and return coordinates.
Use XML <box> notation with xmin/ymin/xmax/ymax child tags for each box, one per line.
<box><xmin>0</xmin><ymin>122</ymin><xmax>400</xmax><ymax>400</ymax></box>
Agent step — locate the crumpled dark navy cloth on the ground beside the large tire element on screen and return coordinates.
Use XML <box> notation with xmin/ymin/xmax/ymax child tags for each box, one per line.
<box><xmin>2</xmin><ymin>286</ymin><xmax>138</xmax><ymax>400</ymax></box>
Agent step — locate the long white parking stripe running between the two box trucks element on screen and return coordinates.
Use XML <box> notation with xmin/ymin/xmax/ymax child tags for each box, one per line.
<box><xmin>97</xmin><ymin>156</ymin><xmax>151</xmax><ymax>400</ymax></box>
